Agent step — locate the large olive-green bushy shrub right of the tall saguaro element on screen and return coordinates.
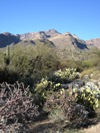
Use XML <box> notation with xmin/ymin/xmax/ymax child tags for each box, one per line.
<box><xmin>9</xmin><ymin>45</ymin><xmax>60</xmax><ymax>86</ymax></box>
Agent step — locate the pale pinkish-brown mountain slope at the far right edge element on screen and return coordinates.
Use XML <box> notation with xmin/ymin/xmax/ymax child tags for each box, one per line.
<box><xmin>86</xmin><ymin>38</ymin><xmax>100</xmax><ymax>48</ymax></box>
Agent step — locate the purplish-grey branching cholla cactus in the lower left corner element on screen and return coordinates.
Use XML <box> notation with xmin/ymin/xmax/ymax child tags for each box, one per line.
<box><xmin>0</xmin><ymin>82</ymin><xmax>38</xmax><ymax>128</ymax></box>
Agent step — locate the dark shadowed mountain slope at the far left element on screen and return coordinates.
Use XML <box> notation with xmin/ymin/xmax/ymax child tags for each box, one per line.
<box><xmin>0</xmin><ymin>32</ymin><xmax>20</xmax><ymax>48</ymax></box>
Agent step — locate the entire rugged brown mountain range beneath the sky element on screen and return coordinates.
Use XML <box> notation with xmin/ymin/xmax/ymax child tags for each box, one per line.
<box><xmin>0</xmin><ymin>29</ymin><xmax>100</xmax><ymax>50</ymax></box>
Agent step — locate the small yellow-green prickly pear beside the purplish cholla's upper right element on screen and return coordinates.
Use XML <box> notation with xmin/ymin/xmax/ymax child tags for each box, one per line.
<box><xmin>34</xmin><ymin>78</ymin><xmax>61</xmax><ymax>105</ymax></box>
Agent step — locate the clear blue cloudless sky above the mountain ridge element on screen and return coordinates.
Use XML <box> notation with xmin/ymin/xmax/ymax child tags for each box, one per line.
<box><xmin>0</xmin><ymin>0</ymin><xmax>100</xmax><ymax>40</ymax></box>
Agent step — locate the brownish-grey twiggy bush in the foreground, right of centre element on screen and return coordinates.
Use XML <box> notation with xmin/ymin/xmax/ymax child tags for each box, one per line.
<box><xmin>44</xmin><ymin>89</ymin><xmax>88</xmax><ymax>121</ymax></box>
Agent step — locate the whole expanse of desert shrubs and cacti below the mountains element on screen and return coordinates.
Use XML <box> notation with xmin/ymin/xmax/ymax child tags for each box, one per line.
<box><xmin>0</xmin><ymin>41</ymin><xmax>100</xmax><ymax>133</ymax></box>
